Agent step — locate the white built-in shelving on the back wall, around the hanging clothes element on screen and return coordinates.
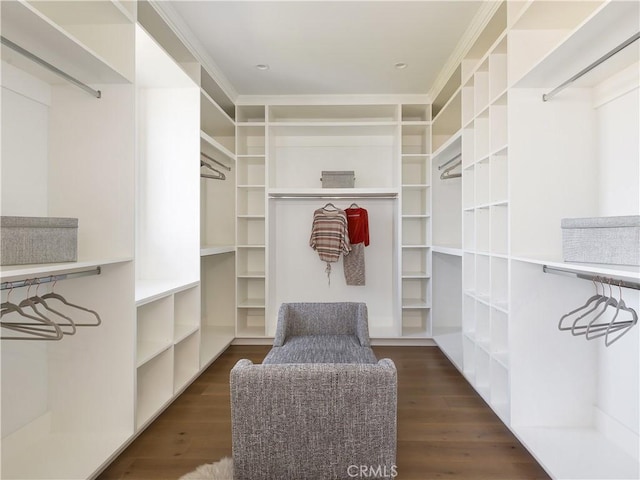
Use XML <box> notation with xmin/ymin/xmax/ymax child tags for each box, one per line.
<box><xmin>236</xmin><ymin>103</ymin><xmax>412</xmax><ymax>337</ymax></box>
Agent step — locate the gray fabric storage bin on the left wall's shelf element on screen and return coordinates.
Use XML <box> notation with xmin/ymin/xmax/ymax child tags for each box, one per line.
<box><xmin>0</xmin><ymin>216</ymin><xmax>78</xmax><ymax>265</ymax></box>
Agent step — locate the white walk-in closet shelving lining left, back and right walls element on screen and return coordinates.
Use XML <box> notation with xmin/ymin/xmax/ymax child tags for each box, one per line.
<box><xmin>0</xmin><ymin>0</ymin><xmax>640</xmax><ymax>480</ymax></box>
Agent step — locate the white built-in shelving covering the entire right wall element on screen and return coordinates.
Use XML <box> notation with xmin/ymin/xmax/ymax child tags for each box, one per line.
<box><xmin>432</xmin><ymin>1</ymin><xmax>640</xmax><ymax>479</ymax></box>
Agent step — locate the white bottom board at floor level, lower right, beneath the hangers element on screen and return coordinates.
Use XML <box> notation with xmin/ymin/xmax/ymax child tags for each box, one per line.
<box><xmin>512</xmin><ymin>426</ymin><xmax>640</xmax><ymax>480</ymax></box>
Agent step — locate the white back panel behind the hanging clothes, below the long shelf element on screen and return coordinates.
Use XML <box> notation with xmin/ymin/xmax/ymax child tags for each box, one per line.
<box><xmin>267</xmin><ymin>199</ymin><xmax>397</xmax><ymax>336</ymax></box>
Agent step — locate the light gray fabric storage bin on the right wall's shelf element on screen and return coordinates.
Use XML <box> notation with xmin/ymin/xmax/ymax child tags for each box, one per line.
<box><xmin>561</xmin><ymin>215</ymin><xmax>640</xmax><ymax>266</ymax></box>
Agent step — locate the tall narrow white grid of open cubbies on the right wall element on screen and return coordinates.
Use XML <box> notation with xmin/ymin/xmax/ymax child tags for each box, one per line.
<box><xmin>462</xmin><ymin>16</ymin><xmax>510</xmax><ymax>423</ymax></box>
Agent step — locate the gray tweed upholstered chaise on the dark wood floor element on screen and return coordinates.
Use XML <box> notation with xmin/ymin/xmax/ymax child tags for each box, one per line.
<box><xmin>231</xmin><ymin>303</ymin><xmax>397</xmax><ymax>480</ymax></box>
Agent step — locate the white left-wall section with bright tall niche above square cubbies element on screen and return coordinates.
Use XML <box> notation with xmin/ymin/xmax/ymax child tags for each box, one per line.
<box><xmin>134</xmin><ymin>21</ymin><xmax>201</xmax><ymax>436</ymax></box>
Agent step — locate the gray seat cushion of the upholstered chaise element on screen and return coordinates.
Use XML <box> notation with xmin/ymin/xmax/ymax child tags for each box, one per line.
<box><xmin>262</xmin><ymin>335</ymin><xmax>378</xmax><ymax>364</ymax></box>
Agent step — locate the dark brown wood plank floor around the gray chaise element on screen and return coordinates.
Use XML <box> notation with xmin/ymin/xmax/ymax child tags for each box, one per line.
<box><xmin>98</xmin><ymin>346</ymin><xmax>549</xmax><ymax>480</ymax></box>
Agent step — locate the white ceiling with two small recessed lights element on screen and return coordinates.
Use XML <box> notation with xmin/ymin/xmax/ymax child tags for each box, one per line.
<box><xmin>164</xmin><ymin>0</ymin><xmax>486</xmax><ymax>95</ymax></box>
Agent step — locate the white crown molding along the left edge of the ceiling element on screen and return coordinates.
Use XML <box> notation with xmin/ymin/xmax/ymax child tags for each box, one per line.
<box><xmin>148</xmin><ymin>0</ymin><xmax>238</xmax><ymax>103</ymax></box>
